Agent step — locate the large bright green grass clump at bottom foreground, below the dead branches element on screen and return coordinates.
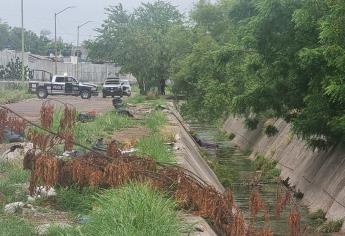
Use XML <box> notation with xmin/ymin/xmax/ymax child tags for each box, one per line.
<box><xmin>81</xmin><ymin>184</ymin><xmax>181</xmax><ymax>236</ymax></box>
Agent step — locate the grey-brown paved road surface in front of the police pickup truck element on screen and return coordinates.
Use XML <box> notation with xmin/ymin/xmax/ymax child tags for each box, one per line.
<box><xmin>6</xmin><ymin>96</ymin><xmax>113</xmax><ymax>121</ymax></box>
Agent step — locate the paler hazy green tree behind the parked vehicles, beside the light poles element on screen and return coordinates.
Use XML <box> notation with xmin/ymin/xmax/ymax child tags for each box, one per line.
<box><xmin>87</xmin><ymin>1</ymin><xmax>182</xmax><ymax>93</ymax></box>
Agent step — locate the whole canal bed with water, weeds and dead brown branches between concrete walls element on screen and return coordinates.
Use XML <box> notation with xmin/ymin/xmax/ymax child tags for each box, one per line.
<box><xmin>189</xmin><ymin>121</ymin><xmax>318</xmax><ymax>235</ymax></box>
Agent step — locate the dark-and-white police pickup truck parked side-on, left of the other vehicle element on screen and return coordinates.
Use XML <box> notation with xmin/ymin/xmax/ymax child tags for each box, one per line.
<box><xmin>29</xmin><ymin>75</ymin><xmax>98</xmax><ymax>99</ymax></box>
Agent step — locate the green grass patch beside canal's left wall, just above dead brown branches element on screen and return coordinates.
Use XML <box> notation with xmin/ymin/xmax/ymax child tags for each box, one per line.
<box><xmin>136</xmin><ymin>133</ymin><xmax>175</xmax><ymax>163</ymax></box>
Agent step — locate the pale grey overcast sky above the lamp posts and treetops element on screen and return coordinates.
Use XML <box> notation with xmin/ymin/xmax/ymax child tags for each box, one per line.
<box><xmin>0</xmin><ymin>0</ymin><xmax>196</xmax><ymax>44</ymax></box>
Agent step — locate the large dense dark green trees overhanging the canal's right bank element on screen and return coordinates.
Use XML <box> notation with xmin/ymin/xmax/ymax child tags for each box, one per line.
<box><xmin>174</xmin><ymin>0</ymin><xmax>345</xmax><ymax>149</ymax></box>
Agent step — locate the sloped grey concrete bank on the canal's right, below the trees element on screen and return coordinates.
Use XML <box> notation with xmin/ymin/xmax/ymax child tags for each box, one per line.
<box><xmin>224</xmin><ymin>117</ymin><xmax>345</xmax><ymax>227</ymax></box>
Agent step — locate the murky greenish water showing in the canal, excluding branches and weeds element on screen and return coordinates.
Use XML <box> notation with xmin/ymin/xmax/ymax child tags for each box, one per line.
<box><xmin>189</xmin><ymin>122</ymin><xmax>316</xmax><ymax>236</ymax></box>
